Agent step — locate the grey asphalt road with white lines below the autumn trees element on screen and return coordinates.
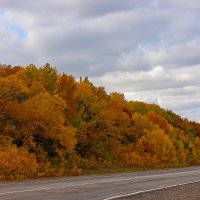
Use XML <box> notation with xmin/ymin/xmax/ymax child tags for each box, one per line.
<box><xmin>0</xmin><ymin>167</ymin><xmax>200</xmax><ymax>200</ymax></box>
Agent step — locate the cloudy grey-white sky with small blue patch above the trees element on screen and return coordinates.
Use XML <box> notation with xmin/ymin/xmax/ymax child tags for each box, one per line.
<box><xmin>0</xmin><ymin>0</ymin><xmax>200</xmax><ymax>122</ymax></box>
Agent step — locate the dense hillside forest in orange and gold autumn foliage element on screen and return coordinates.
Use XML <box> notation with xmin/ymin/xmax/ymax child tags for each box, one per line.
<box><xmin>0</xmin><ymin>64</ymin><xmax>200</xmax><ymax>180</ymax></box>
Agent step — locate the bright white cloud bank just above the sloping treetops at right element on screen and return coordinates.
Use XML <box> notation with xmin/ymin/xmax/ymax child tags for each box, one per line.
<box><xmin>92</xmin><ymin>65</ymin><xmax>200</xmax><ymax>120</ymax></box>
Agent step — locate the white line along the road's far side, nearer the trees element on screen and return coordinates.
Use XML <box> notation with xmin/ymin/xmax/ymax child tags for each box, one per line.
<box><xmin>0</xmin><ymin>170</ymin><xmax>200</xmax><ymax>195</ymax></box>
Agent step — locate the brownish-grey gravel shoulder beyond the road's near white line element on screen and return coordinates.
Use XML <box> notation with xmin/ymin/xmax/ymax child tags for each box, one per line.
<box><xmin>116</xmin><ymin>182</ymin><xmax>200</xmax><ymax>200</ymax></box>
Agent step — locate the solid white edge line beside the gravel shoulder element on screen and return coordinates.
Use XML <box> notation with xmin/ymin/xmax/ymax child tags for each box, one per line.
<box><xmin>103</xmin><ymin>180</ymin><xmax>200</xmax><ymax>200</ymax></box>
